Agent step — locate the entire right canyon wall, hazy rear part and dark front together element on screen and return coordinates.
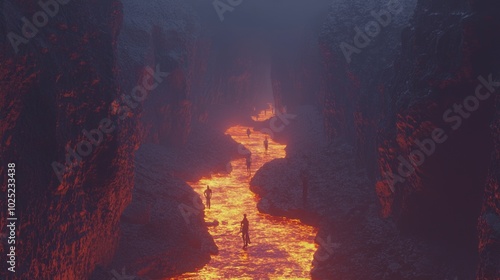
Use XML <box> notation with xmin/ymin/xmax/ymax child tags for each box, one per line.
<box><xmin>321</xmin><ymin>1</ymin><xmax>500</xmax><ymax>279</ymax></box>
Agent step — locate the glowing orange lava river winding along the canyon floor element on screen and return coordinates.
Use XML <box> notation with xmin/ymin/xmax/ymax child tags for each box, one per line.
<box><xmin>177</xmin><ymin>119</ymin><xmax>317</xmax><ymax>279</ymax></box>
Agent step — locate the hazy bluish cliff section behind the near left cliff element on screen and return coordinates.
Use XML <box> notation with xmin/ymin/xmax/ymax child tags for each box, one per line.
<box><xmin>118</xmin><ymin>0</ymin><xmax>200</xmax><ymax>147</ymax></box>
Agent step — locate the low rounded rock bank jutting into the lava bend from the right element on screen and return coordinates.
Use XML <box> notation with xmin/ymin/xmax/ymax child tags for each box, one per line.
<box><xmin>250</xmin><ymin>106</ymin><xmax>328</xmax><ymax>224</ymax></box>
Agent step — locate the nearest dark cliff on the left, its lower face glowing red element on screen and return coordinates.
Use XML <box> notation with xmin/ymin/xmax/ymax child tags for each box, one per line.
<box><xmin>0</xmin><ymin>1</ymin><xmax>133</xmax><ymax>280</ymax></box>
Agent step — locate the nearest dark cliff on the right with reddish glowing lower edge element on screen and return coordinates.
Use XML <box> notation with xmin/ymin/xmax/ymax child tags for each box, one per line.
<box><xmin>377</xmin><ymin>1</ymin><xmax>500</xmax><ymax>279</ymax></box>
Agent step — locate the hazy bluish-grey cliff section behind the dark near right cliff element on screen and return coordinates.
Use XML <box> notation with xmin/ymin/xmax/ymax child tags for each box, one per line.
<box><xmin>319</xmin><ymin>0</ymin><xmax>416</xmax><ymax>180</ymax></box>
